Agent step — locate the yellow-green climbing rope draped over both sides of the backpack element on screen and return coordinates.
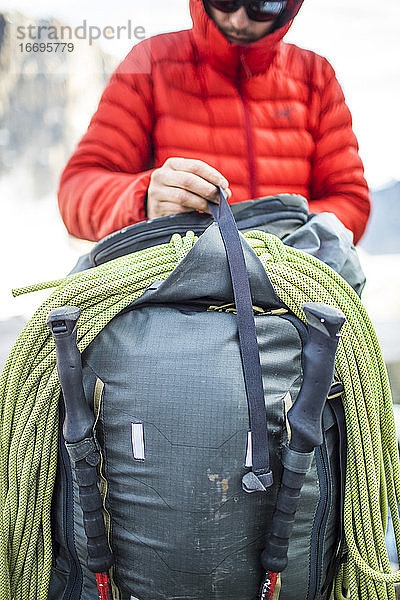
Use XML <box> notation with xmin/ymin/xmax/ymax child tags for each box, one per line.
<box><xmin>0</xmin><ymin>231</ymin><xmax>400</xmax><ymax>600</ymax></box>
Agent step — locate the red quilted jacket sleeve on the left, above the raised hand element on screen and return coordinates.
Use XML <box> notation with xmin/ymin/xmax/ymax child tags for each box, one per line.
<box><xmin>58</xmin><ymin>44</ymin><xmax>153</xmax><ymax>240</ymax></box>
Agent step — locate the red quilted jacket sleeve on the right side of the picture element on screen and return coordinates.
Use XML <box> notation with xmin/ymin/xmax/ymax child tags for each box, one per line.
<box><xmin>310</xmin><ymin>59</ymin><xmax>370</xmax><ymax>243</ymax></box>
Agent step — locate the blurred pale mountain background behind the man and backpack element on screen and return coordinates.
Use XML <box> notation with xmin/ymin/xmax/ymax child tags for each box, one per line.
<box><xmin>0</xmin><ymin>0</ymin><xmax>400</xmax><ymax>402</ymax></box>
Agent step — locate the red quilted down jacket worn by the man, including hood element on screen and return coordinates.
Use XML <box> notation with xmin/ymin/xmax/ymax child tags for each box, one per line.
<box><xmin>59</xmin><ymin>0</ymin><xmax>370</xmax><ymax>242</ymax></box>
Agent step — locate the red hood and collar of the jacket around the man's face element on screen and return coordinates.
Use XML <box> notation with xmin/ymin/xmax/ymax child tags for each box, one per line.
<box><xmin>189</xmin><ymin>0</ymin><xmax>304</xmax><ymax>77</ymax></box>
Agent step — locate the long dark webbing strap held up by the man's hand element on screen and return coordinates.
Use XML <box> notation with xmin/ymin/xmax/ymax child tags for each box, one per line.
<box><xmin>208</xmin><ymin>188</ymin><xmax>273</xmax><ymax>492</ymax></box>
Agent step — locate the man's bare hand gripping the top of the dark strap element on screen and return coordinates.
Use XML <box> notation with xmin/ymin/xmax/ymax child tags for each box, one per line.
<box><xmin>147</xmin><ymin>158</ymin><xmax>232</xmax><ymax>219</ymax></box>
